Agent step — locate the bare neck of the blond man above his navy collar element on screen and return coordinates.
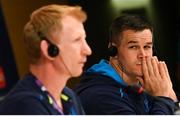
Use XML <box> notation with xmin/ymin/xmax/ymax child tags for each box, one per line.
<box><xmin>30</xmin><ymin>63</ymin><xmax>69</xmax><ymax>108</ymax></box>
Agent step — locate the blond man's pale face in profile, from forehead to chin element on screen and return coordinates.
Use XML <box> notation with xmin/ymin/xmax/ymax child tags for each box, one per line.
<box><xmin>51</xmin><ymin>16</ymin><xmax>91</xmax><ymax>77</ymax></box>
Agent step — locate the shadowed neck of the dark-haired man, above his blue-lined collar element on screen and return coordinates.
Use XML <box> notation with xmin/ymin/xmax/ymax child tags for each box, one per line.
<box><xmin>110</xmin><ymin>58</ymin><xmax>138</xmax><ymax>85</ymax></box>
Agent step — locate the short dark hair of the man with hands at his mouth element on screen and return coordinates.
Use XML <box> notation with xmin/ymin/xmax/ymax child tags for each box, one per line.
<box><xmin>109</xmin><ymin>14</ymin><xmax>153</xmax><ymax>43</ymax></box>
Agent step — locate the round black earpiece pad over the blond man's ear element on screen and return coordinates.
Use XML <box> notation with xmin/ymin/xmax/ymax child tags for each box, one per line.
<box><xmin>48</xmin><ymin>43</ymin><xmax>59</xmax><ymax>57</ymax></box>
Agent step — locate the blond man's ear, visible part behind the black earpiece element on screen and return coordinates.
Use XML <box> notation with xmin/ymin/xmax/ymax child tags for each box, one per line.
<box><xmin>40</xmin><ymin>40</ymin><xmax>54</xmax><ymax>60</ymax></box>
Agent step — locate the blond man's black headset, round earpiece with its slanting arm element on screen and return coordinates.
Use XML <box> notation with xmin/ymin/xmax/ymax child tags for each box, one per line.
<box><xmin>38</xmin><ymin>32</ymin><xmax>60</xmax><ymax>57</ymax></box>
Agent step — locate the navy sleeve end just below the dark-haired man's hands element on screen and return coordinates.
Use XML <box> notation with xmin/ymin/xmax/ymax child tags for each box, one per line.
<box><xmin>150</xmin><ymin>96</ymin><xmax>175</xmax><ymax>115</ymax></box>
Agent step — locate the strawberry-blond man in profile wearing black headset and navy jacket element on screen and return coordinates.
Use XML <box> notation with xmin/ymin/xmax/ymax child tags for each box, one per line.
<box><xmin>0</xmin><ymin>4</ymin><xmax>91</xmax><ymax>115</ymax></box>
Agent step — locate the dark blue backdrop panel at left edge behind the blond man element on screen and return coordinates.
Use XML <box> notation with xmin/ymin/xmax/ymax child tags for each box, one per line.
<box><xmin>0</xmin><ymin>6</ymin><xmax>18</xmax><ymax>96</ymax></box>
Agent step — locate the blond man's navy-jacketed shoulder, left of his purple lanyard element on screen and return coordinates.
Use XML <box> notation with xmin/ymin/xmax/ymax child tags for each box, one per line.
<box><xmin>0</xmin><ymin>75</ymin><xmax>50</xmax><ymax>114</ymax></box>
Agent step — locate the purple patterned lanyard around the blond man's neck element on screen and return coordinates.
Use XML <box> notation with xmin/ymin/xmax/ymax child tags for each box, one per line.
<box><xmin>35</xmin><ymin>79</ymin><xmax>64</xmax><ymax>115</ymax></box>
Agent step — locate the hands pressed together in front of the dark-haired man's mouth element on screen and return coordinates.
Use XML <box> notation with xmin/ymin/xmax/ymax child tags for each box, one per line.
<box><xmin>138</xmin><ymin>57</ymin><xmax>176</xmax><ymax>100</ymax></box>
